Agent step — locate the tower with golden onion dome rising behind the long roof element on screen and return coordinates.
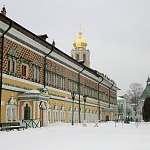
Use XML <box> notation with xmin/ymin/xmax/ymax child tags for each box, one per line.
<box><xmin>71</xmin><ymin>26</ymin><xmax>90</xmax><ymax>67</ymax></box>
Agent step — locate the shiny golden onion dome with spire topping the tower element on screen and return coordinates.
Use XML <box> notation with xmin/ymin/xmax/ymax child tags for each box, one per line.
<box><xmin>73</xmin><ymin>27</ymin><xmax>87</xmax><ymax>50</ymax></box>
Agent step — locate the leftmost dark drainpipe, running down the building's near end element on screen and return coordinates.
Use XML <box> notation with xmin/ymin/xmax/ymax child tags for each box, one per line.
<box><xmin>0</xmin><ymin>20</ymin><xmax>13</xmax><ymax>123</ymax></box>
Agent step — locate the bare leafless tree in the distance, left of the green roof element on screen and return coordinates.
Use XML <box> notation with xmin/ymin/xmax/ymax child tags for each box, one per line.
<box><xmin>124</xmin><ymin>83</ymin><xmax>143</xmax><ymax>105</ymax></box>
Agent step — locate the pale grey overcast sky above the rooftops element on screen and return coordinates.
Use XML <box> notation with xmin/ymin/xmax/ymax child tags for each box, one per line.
<box><xmin>0</xmin><ymin>0</ymin><xmax>150</xmax><ymax>95</ymax></box>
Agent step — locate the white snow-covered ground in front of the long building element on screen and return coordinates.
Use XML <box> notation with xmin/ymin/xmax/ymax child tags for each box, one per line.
<box><xmin>0</xmin><ymin>122</ymin><xmax>150</xmax><ymax>150</ymax></box>
